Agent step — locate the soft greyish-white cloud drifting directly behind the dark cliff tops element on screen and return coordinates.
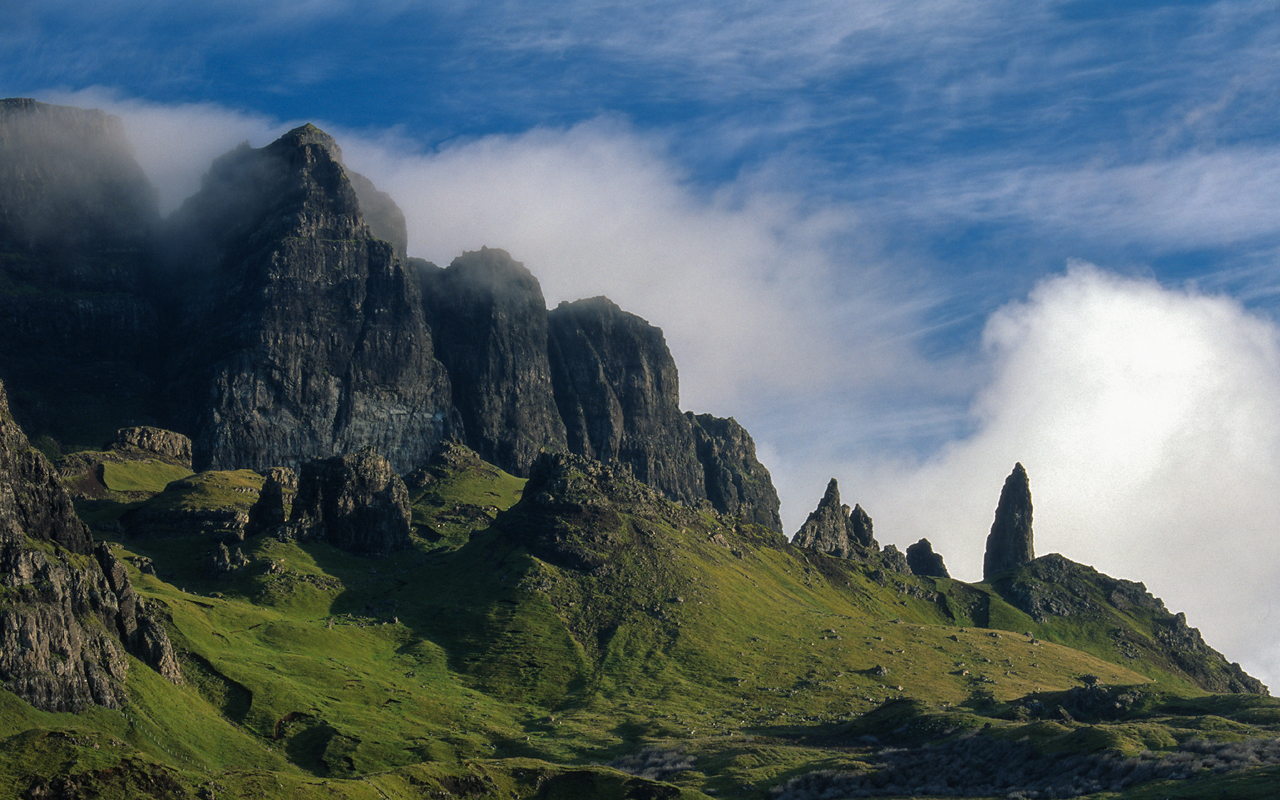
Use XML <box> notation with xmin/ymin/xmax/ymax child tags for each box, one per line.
<box><xmin>342</xmin><ymin>119</ymin><xmax>937</xmax><ymax>415</ymax></box>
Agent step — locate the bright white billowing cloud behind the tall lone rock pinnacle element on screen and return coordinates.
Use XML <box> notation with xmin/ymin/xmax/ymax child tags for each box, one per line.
<box><xmin>847</xmin><ymin>264</ymin><xmax>1280</xmax><ymax>685</ymax></box>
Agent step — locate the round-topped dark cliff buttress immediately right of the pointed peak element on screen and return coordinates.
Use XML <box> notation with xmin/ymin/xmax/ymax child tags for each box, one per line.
<box><xmin>424</xmin><ymin>247</ymin><xmax>564</xmax><ymax>475</ymax></box>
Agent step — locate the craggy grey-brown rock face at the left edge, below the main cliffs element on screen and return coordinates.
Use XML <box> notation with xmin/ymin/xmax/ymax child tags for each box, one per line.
<box><xmin>0</xmin><ymin>376</ymin><xmax>180</xmax><ymax>710</ymax></box>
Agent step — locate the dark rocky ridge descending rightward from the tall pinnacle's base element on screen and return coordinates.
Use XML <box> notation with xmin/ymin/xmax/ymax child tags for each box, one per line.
<box><xmin>995</xmin><ymin>553</ymin><xmax>1268</xmax><ymax>695</ymax></box>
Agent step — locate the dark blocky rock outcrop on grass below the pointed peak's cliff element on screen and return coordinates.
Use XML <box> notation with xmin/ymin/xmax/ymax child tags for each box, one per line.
<box><xmin>287</xmin><ymin>448</ymin><xmax>410</xmax><ymax>556</ymax></box>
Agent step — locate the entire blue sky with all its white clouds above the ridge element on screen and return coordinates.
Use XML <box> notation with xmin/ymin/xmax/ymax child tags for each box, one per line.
<box><xmin>0</xmin><ymin>0</ymin><xmax>1280</xmax><ymax>685</ymax></box>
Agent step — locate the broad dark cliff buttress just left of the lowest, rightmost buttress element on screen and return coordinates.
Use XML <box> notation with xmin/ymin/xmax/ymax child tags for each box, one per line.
<box><xmin>548</xmin><ymin>297</ymin><xmax>707</xmax><ymax>503</ymax></box>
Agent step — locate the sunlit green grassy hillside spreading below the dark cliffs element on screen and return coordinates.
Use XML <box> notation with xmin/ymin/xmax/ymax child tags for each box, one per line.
<box><xmin>0</xmin><ymin>451</ymin><xmax>1280</xmax><ymax>797</ymax></box>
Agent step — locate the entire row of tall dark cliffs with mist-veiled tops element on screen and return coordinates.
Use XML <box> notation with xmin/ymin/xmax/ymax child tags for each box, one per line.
<box><xmin>0</xmin><ymin>100</ymin><xmax>781</xmax><ymax>529</ymax></box>
